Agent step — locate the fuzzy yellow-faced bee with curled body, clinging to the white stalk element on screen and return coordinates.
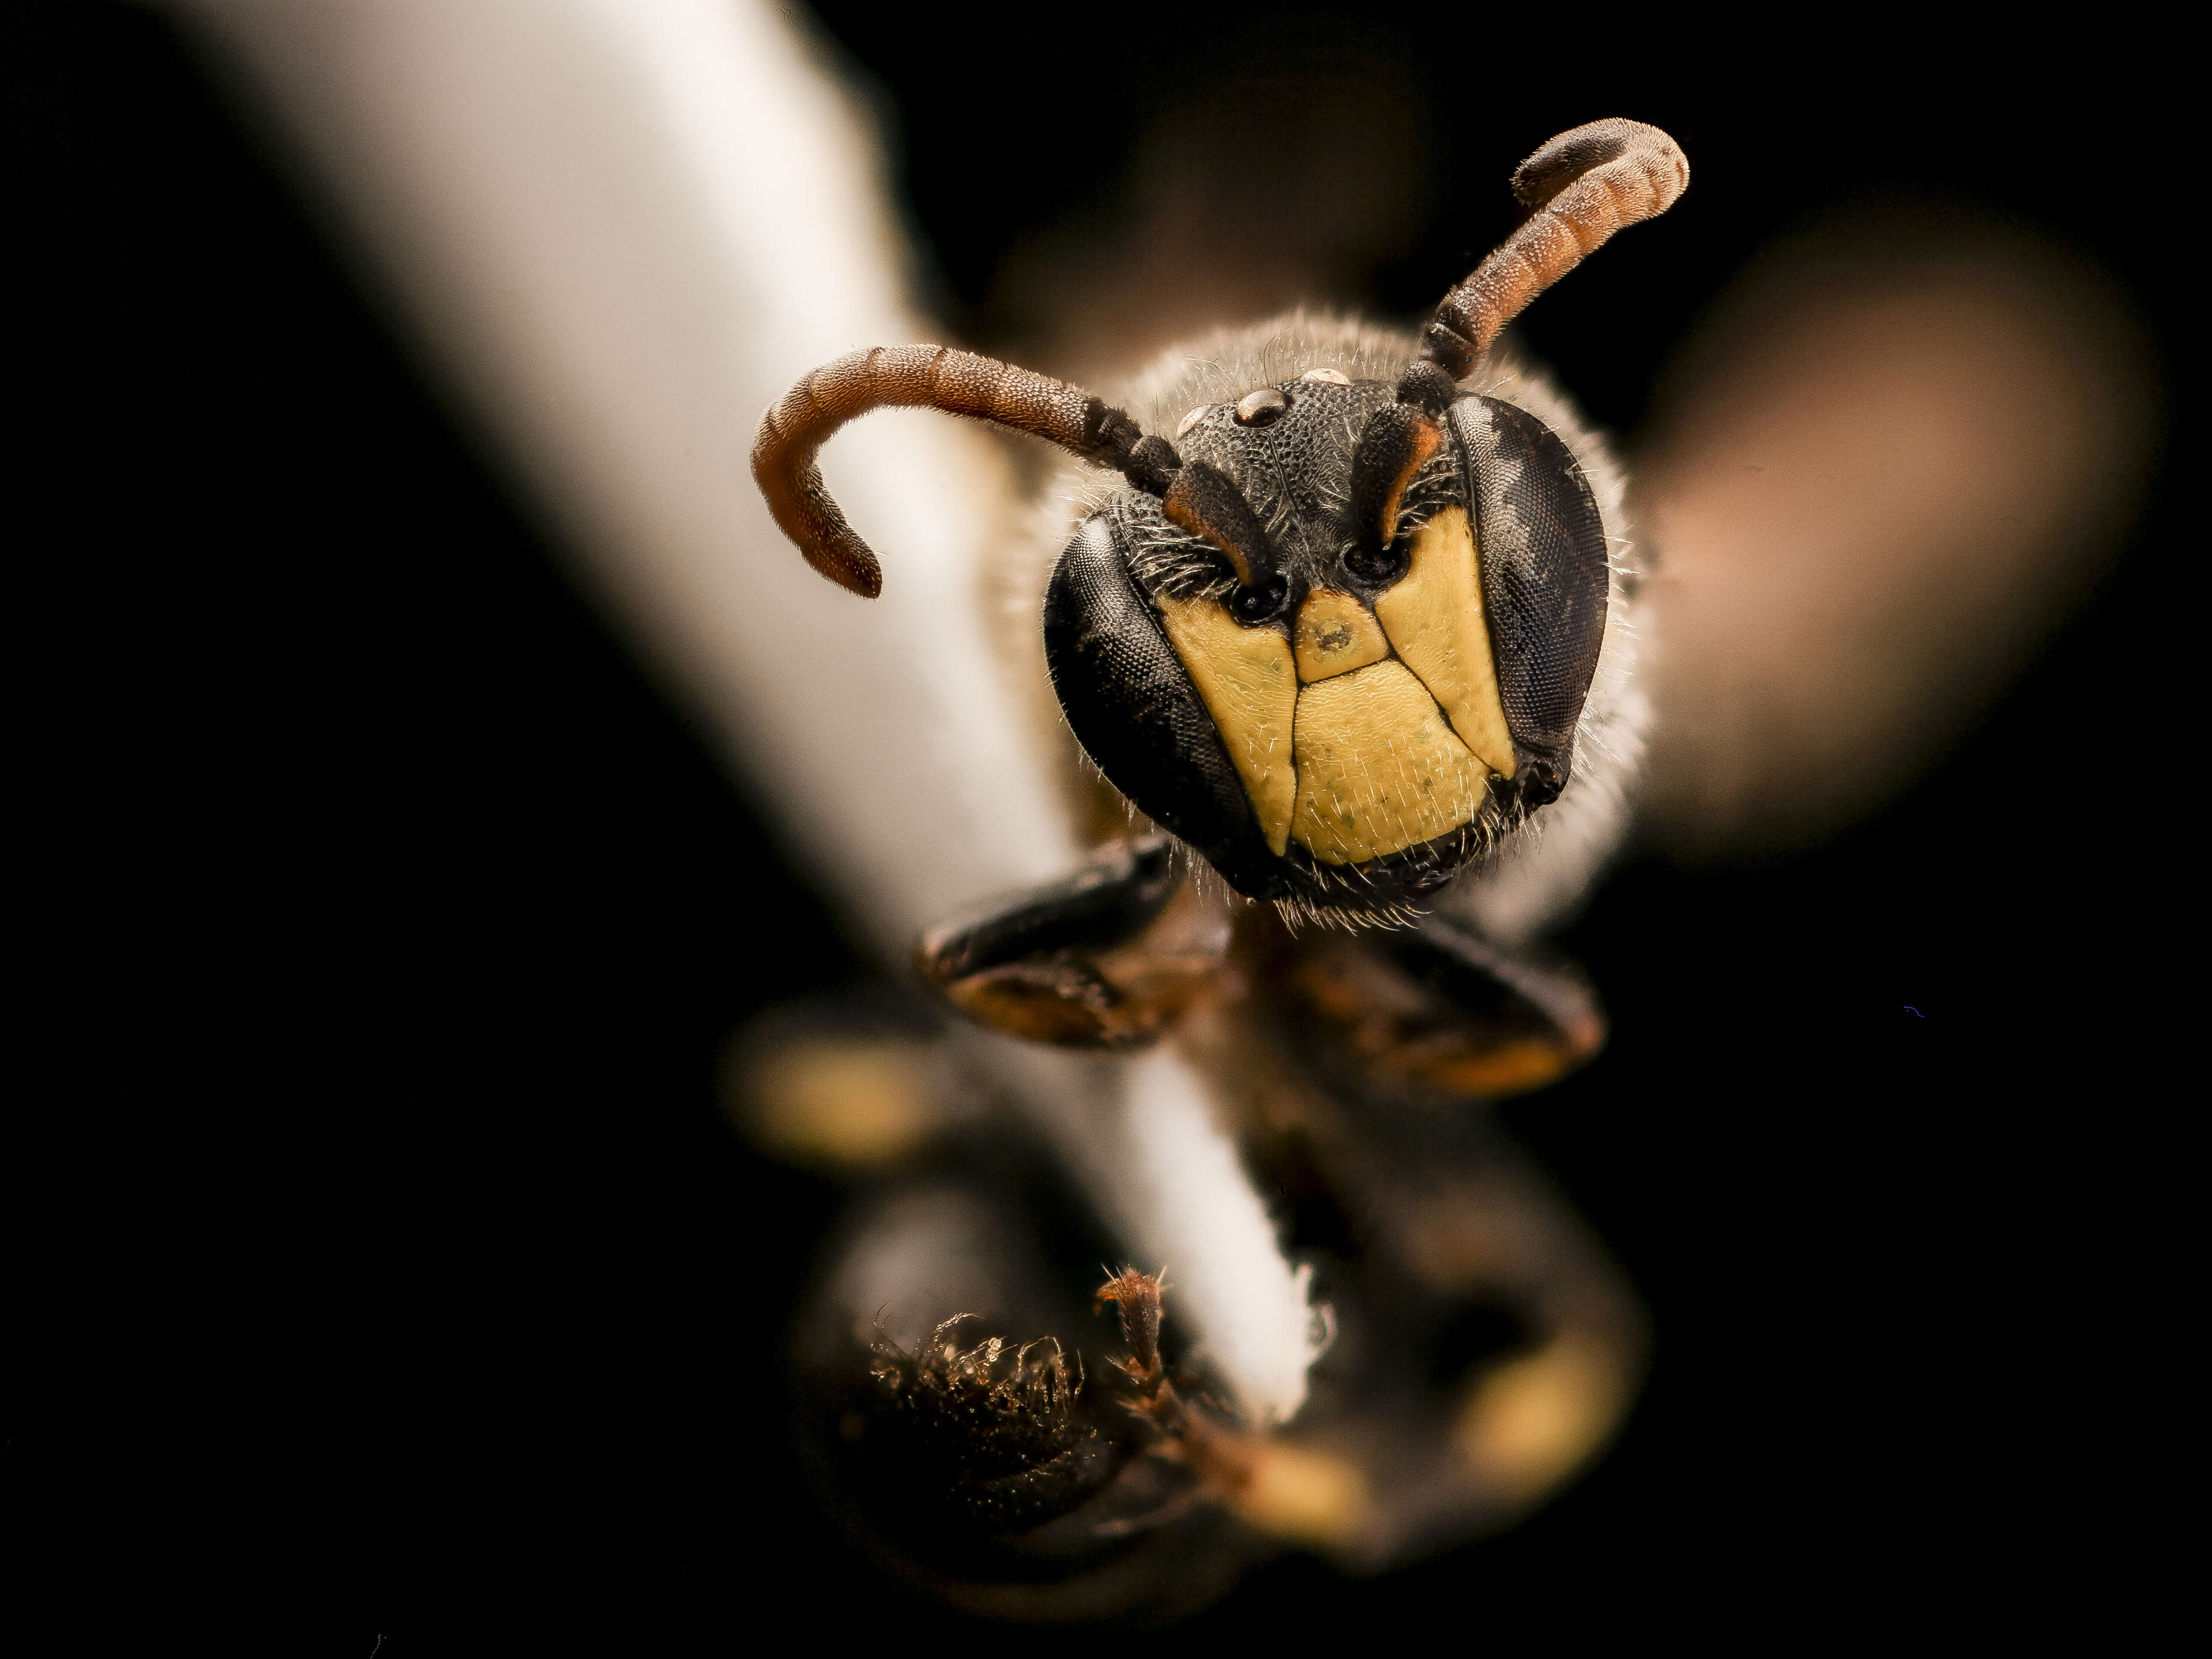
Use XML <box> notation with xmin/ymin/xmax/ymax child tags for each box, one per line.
<box><xmin>752</xmin><ymin>119</ymin><xmax>1688</xmax><ymax>1612</ymax></box>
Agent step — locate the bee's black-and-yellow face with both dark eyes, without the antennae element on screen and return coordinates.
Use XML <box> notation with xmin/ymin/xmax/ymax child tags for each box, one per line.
<box><xmin>1044</xmin><ymin>372</ymin><xmax>1608</xmax><ymax>909</ymax></box>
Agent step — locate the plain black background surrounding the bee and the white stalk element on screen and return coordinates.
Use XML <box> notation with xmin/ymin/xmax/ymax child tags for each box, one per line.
<box><xmin>0</xmin><ymin>4</ymin><xmax>2201</xmax><ymax>1655</ymax></box>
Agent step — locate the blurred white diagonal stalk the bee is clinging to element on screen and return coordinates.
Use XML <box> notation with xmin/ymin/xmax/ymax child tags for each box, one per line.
<box><xmin>177</xmin><ymin>0</ymin><xmax>1309</xmax><ymax>1420</ymax></box>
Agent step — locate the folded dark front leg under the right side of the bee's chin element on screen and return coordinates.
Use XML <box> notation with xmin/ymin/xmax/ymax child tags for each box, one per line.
<box><xmin>1274</xmin><ymin>916</ymin><xmax>1606</xmax><ymax>1100</ymax></box>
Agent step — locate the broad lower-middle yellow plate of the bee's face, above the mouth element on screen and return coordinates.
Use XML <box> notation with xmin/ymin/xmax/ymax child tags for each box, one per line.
<box><xmin>1292</xmin><ymin>661</ymin><xmax>1489</xmax><ymax>865</ymax></box>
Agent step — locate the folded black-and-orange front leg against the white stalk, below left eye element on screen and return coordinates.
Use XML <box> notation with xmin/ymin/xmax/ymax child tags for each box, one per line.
<box><xmin>916</xmin><ymin>834</ymin><xmax>1230</xmax><ymax>1049</ymax></box>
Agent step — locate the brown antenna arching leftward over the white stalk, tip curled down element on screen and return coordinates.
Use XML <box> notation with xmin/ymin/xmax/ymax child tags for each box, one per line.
<box><xmin>752</xmin><ymin>345</ymin><xmax>1181</xmax><ymax>600</ymax></box>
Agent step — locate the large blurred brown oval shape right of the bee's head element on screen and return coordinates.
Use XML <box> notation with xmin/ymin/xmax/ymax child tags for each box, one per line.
<box><xmin>1635</xmin><ymin>217</ymin><xmax>2157</xmax><ymax>858</ymax></box>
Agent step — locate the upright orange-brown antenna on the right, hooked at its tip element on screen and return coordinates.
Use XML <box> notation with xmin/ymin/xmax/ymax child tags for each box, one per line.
<box><xmin>1398</xmin><ymin>119</ymin><xmax>1690</xmax><ymax>416</ymax></box>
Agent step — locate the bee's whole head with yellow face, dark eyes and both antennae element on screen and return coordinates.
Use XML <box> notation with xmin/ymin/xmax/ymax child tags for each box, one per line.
<box><xmin>752</xmin><ymin>119</ymin><xmax>1690</xmax><ymax>914</ymax></box>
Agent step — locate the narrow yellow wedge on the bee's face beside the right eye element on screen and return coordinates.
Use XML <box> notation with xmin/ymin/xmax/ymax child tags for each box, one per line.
<box><xmin>1371</xmin><ymin>506</ymin><xmax>1513</xmax><ymax>776</ymax></box>
